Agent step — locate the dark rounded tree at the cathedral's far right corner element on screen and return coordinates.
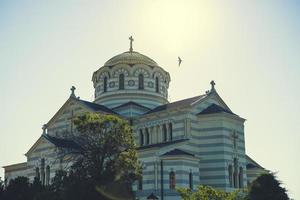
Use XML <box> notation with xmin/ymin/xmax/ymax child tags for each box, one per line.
<box><xmin>249</xmin><ymin>173</ymin><xmax>289</xmax><ymax>200</ymax></box>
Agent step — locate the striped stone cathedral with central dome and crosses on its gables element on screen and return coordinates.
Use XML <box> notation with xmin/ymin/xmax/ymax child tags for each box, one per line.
<box><xmin>4</xmin><ymin>37</ymin><xmax>267</xmax><ymax>200</ymax></box>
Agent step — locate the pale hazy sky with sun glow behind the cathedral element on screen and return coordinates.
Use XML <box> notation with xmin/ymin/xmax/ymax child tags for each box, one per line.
<box><xmin>0</xmin><ymin>0</ymin><xmax>300</xmax><ymax>199</ymax></box>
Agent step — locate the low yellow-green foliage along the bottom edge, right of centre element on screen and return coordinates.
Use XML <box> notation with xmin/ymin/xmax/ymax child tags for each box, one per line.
<box><xmin>177</xmin><ymin>185</ymin><xmax>246</xmax><ymax>200</ymax></box>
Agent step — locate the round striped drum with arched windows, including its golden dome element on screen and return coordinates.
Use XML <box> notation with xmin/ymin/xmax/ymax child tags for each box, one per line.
<box><xmin>92</xmin><ymin>52</ymin><xmax>170</xmax><ymax>108</ymax></box>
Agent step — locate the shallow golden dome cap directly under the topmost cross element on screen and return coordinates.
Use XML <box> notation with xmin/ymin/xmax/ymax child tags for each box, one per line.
<box><xmin>104</xmin><ymin>51</ymin><xmax>158</xmax><ymax>67</ymax></box>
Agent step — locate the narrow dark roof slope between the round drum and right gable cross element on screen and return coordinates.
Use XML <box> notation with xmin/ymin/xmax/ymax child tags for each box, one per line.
<box><xmin>146</xmin><ymin>94</ymin><xmax>207</xmax><ymax>114</ymax></box>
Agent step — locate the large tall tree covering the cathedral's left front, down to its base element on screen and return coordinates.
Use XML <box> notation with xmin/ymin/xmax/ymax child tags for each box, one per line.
<box><xmin>53</xmin><ymin>113</ymin><xmax>141</xmax><ymax>200</ymax></box>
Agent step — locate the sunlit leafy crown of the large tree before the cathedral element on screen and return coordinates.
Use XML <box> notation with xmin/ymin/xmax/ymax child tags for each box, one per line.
<box><xmin>73</xmin><ymin>114</ymin><xmax>141</xmax><ymax>185</ymax></box>
